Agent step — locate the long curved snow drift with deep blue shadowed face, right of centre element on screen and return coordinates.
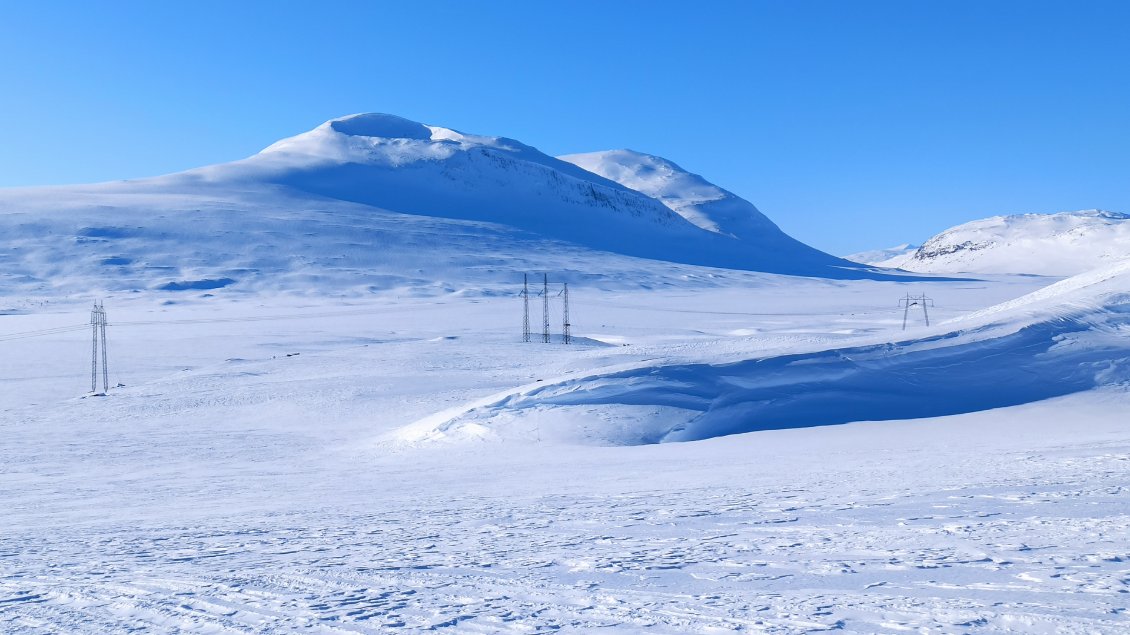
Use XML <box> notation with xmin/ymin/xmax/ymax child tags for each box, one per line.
<box><xmin>399</xmin><ymin>262</ymin><xmax>1130</xmax><ymax>444</ymax></box>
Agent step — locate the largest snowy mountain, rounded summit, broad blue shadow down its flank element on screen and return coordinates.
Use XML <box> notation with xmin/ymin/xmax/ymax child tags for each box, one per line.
<box><xmin>0</xmin><ymin>114</ymin><xmax>887</xmax><ymax>294</ymax></box>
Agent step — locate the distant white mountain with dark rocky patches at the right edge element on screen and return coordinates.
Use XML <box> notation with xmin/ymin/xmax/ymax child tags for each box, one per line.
<box><xmin>870</xmin><ymin>209</ymin><xmax>1130</xmax><ymax>276</ymax></box>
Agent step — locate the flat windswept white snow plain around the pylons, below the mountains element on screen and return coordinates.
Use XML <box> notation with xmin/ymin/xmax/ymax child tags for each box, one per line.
<box><xmin>0</xmin><ymin>262</ymin><xmax>1130</xmax><ymax>634</ymax></box>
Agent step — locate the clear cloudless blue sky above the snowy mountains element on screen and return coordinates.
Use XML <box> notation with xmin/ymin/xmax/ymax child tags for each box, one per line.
<box><xmin>0</xmin><ymin>0</ymin><xmax>1130</xmax><ymax>254</ymax></box>
